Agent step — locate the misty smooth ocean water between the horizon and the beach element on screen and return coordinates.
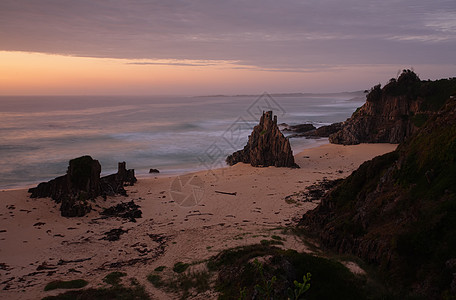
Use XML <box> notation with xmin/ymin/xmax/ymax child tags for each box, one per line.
<box><xmin>0</xmin><ymin>92</ymin><xmax>365</xmax><ymax>189</ymax></box>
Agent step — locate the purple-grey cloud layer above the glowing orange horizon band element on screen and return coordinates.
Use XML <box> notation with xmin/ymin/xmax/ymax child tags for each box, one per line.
<box><xmin>0</xmin><ymin>0</ymin><xmax>456</xmax><ymax>70</ymax></box>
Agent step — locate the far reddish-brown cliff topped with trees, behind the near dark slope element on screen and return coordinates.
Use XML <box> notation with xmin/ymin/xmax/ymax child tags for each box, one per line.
<box><xmin>329</xmin><ymin>70</ymin><xmax>456</xmax><ymax>145</ymax></box>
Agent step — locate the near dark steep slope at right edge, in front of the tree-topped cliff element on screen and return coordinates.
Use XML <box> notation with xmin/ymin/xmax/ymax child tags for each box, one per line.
<box><xmin>301</xmin><ymin>95</ymin><xmax>456</xmax><ymax>299</ymax></box>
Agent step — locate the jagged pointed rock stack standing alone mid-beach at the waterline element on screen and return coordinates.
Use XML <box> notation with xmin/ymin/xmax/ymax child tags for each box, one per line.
<box><xmin>226</xmin><ymin>111</ymin><xmax>299</xmax><ymax>168</ymax></box>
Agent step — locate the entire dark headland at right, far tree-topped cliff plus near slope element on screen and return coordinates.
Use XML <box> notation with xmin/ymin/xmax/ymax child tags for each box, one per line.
<box><xmin>301</xmin><ymin>72</ymin><xmax>456</xmax><ymax>299</ymax></box>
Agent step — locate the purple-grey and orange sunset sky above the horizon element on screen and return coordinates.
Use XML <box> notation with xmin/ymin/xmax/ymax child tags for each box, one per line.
<box><xmin>0</xmin><ymin>0</ymin><xmax>456</xmax><ymax>95</ymax></box>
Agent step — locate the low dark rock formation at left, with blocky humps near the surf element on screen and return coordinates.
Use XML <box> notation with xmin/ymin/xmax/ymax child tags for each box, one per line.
<box><xmin>29</xmin><ymin>156</ymin><xmax>136</xmax><ymax>217</ymax></box>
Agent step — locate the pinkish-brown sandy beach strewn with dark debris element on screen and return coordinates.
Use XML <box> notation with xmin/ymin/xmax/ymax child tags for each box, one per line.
<box><xmin>0</xmin><ymin>144</ymin><xmax>397</xmax><ymax>299</ymax></box>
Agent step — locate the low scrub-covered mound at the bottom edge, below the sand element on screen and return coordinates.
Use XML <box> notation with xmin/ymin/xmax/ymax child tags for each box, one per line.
<box><xmin>147</xmin><ymin>244</ymin><xmax>392</xmax><ymax>299</ymax></box>
